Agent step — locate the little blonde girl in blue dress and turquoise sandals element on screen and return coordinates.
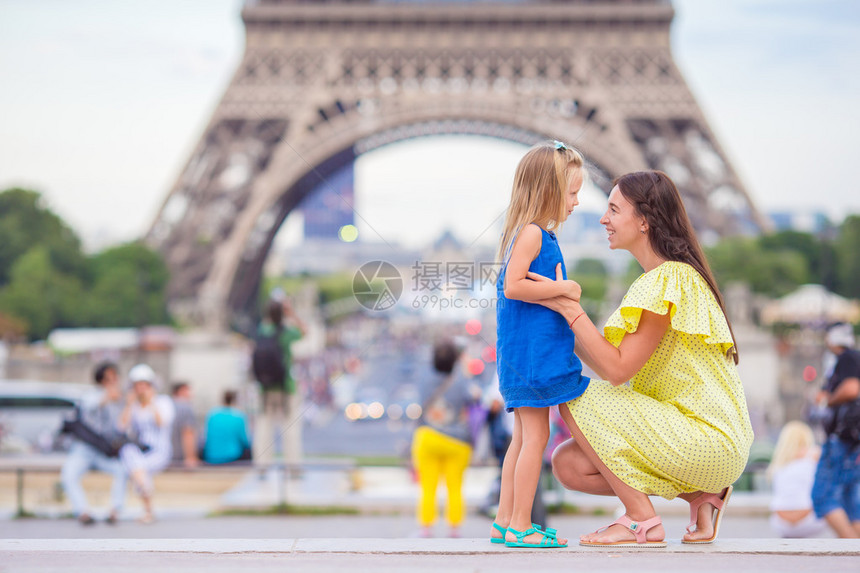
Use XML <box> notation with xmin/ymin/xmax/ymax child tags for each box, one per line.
<box><xmin>490</xmin><ymin>141</ymin><xmax>589</xmax><ymax>547</ymax></box>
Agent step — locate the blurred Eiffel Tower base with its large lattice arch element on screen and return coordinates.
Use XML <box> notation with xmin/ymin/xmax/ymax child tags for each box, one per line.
<box><xmin>147</xmin><ymin>0</ymin><xmax>766</xmax><ymax>329</ymax></box>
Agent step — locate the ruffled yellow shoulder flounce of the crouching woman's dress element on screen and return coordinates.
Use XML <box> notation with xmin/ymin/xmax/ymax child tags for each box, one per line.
<box><xmin>603</xmin><ymin>261</ymin><xmax>734</xmax><ymax>353</ymax></box>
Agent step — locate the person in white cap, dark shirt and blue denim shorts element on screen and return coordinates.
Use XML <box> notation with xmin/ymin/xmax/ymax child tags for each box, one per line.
<box><xmin>812</xmin><ymin>324</ymin><xmax>860</xmax><ymax>538</ymax></box>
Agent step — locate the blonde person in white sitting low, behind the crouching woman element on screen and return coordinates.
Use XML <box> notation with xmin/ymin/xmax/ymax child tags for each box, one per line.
<box><xmin>767</xmin><ymin>420</ymin><xmax>827</xmax><ymax>537</ymax></box>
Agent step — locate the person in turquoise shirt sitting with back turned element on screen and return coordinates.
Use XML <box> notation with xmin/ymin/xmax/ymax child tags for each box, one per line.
<box><xmin>203</xmin><ymin>390</ymin><xmax>251</xmax><ymax>464</ymax></box>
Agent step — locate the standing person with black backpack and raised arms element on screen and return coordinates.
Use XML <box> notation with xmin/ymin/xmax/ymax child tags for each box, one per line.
<box><xmin>252</xmin><ymin>296</ymin><xmax>306</xmax><ymax>470</ymax></box>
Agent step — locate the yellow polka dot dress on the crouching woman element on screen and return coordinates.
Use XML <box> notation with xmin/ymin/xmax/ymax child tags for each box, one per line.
<box><xmin>568</xmin><ymin>261</ymin><xmax>753</xmax><ymax>499</ymax></box>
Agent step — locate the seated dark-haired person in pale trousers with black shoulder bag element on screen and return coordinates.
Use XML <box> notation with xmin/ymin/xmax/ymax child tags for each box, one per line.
<box><xmin>60</xmin><ymin>362</ymin><xmax>127</xmax><ymax>525</ymax></box>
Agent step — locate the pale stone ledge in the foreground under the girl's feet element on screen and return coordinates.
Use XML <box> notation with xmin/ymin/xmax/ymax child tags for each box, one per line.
<box><xmin>0</xmin><ymin>539</ymin><xmax>860</xmax><ymax>573</ymax></box>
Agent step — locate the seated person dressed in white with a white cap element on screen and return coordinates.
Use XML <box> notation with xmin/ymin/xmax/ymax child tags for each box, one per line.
<box><xmin>119</xmin><ymin>364</ymin><xmax>174</xmax><ymax>523</ymax></box>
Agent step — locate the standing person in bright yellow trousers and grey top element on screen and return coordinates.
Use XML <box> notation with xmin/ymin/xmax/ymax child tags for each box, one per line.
<box><xmin>412</xmin><ymin>339</ymin><xmax>477</xmax><ymax>537</ymax></box>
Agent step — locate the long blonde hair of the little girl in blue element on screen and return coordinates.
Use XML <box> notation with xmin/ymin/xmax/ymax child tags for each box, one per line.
<box><xmin>496</xmin><ymin>141</ymin><xmax>585</xmax><ymax>262</ymax></box>
